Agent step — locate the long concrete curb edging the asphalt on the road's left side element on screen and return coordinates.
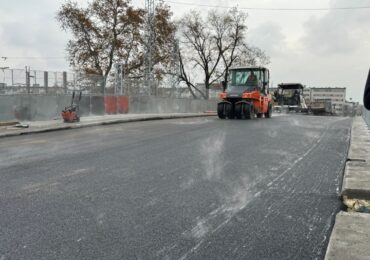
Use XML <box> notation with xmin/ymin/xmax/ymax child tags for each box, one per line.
<box><xmin>0</xmin><ymin>113</ymin><xmax>216</xmax><ymax>138</ymax></box>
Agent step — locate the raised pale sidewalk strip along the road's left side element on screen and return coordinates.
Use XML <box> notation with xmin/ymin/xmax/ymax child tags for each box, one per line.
<box><xmin>0</xmin><ymin>112</ymin><xmax>216</xmax><ymax>138</ymax></box>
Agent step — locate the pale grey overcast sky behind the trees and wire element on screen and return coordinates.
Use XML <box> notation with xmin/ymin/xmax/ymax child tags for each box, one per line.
<box><xmin>0</xmin><ymin>0</ymin><xmax>370</xmax><ymax>102</ymax></box>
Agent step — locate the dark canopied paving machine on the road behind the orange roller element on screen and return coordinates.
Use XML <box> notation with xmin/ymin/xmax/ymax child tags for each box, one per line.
<box><xmin>273</xmin><ymin>83</ymin><xmax>308</xmax><ymax>113</ymax></box>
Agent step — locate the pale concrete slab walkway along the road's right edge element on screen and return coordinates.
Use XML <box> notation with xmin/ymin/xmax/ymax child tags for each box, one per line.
<box><xmin>325</xmin><ymin>117</ymin><xmax>370</xmax><ymax>260</ymax></box>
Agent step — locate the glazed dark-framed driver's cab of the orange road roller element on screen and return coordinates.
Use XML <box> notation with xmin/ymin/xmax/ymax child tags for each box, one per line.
<box><xmin>224</xmin><ymin>67</ymin><xmax>270</xmax><ymax>95</ymax></box>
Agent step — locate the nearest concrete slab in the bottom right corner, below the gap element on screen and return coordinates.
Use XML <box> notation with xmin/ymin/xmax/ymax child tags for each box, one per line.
<box><xmin>325</xmin><ymin>211</ymin><xmax>370</xmax><ymax>260</ymax></box>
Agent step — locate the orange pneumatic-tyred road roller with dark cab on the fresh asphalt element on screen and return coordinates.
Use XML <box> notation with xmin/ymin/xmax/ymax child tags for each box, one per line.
<box><xmin>217</xmin><ymin>67</ymin><xmax>272</xmax><ymax>119</ymax></box>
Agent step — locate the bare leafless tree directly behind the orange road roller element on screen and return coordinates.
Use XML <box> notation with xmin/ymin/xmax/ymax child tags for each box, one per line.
<box><xmin>179</xmin><ymin>8</ymin><xmax>269</xmax><ymax>98</ymax></box>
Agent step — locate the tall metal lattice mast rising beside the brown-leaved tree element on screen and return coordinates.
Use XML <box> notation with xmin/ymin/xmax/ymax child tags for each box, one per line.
<box><xmin>144</xmin><ymin>0</ymin><xmax>155</xmax><ymax>95</ymax></box>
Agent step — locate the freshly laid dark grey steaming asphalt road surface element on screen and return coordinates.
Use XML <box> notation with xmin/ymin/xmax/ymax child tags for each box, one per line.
<box><xmin>0</xmin><ymin>115</ymin><xmax>351</xmax><ymax>260</ymax></box>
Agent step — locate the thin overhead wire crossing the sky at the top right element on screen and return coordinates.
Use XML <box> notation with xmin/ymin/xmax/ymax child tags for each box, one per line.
<box><xmin>164</xmin><ymin>0</ymin><xmax>370</xmax><ymax>11</ymax></box>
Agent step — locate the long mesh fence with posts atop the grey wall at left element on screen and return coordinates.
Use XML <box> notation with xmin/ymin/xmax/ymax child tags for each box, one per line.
<box><xmin>0</xmin><ymin>69</ymin><xmax>220</xmax><ymax>99</ymax></box>
